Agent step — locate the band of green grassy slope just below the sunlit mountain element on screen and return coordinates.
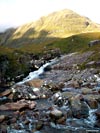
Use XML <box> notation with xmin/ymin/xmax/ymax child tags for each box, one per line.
<box><xmin>0</xmin><ymin>32</ymin><xmax>100</xmax><ymax>54</ymax></box>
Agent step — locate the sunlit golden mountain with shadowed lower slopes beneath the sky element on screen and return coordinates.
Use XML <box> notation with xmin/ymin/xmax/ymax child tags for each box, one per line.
<box><xmin>0</xmin><ymin>9</ymin><xmax>100</xmax><ymax>49</ymax></box>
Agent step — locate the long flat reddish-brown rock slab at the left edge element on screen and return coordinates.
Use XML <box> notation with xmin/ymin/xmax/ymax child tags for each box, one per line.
<box><xmin>0</xmin><ymin>100</ymin><xmax>36</xmax><ymax>110</ymax></box>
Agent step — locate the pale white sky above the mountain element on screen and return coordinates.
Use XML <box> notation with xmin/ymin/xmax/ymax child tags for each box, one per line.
<box><xmin>0</xmin><ymin>0</ymin><xmax>100</xmax><ymax>30</ymax></box>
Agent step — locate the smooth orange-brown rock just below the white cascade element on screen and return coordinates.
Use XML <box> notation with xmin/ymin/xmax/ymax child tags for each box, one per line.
<box><xmin>25</xmin><ymin>79</ymin><xmax>44</xmax><ymax>88</ymax></box>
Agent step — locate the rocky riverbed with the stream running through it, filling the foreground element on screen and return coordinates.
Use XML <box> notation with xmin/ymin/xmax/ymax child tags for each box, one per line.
<box><xmin>0</xmin><ymin>52</ymin><xmax>100</xmax><ymax>133</ymax></box>
